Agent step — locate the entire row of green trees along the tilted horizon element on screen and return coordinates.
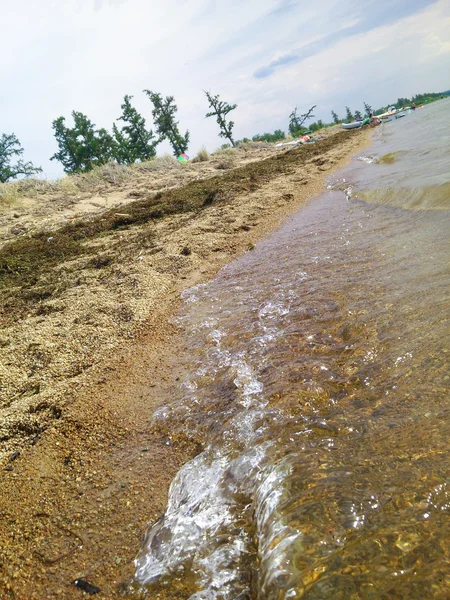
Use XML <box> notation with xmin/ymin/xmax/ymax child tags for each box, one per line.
<box><xmin>0</xmin><ymin>90</ymin><xmax>450</xmax><ymax>183</ymax></box>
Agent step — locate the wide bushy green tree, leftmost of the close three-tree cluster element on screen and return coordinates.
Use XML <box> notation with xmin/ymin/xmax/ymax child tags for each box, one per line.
<box><xmin>50</xmin><ymin>110</ymin><xmax>115</xmax><ymax>173</ymax></box>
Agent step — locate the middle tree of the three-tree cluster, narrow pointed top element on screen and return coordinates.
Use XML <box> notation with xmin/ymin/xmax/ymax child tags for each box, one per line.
<box><xmin>113</xmin><ymin>96</ymin><xmax>159</xmax><ymax>165</ymax></box>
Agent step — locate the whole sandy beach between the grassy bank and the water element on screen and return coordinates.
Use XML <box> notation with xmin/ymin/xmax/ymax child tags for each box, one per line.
<box><xmin>0</xmin><ymin>130</ymin><xmax>370</xmax><ymax>600</ymax></box>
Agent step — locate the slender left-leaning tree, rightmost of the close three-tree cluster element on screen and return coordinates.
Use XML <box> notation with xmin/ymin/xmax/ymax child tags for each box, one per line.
<box><xmin>144</xmin><ymin>90</ymin><xmax>189</xmax><ymax>156</ymax></box>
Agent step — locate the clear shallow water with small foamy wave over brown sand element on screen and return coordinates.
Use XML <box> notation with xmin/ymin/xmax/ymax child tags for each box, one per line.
<box><xmin>136</xmin><ymin>100</ymin><xmax>450</xmax><ymax>600</ymax></box>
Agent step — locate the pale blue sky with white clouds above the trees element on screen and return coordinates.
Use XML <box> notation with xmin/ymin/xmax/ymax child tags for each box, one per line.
<box><xmin>0</xmin><ymin>0</ymin><xmax>450</xmax><ymax>179</ymax></box>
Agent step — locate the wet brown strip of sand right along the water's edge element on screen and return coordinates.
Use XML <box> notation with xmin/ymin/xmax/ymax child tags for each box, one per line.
<box><xmin>0</xmin><ymin>130</ymin><xmax>371</xmax><ymax>600</ymax></box>
